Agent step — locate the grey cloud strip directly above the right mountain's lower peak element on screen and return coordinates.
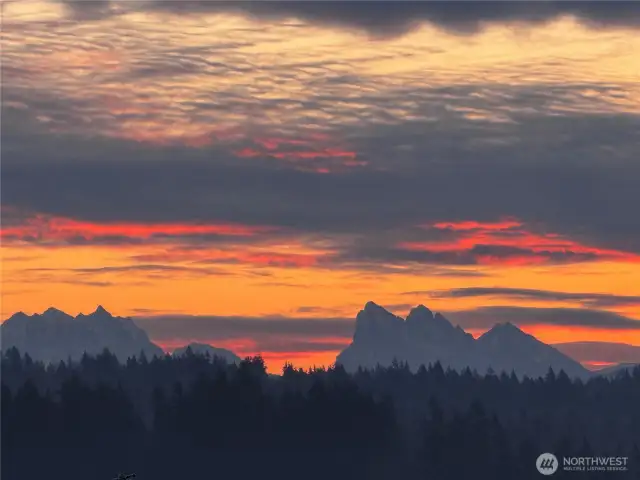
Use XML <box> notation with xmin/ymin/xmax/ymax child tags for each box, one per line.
<box><xmin>446</xmin><ymin>306</ymin><xmax>640</xmax><ymax>330</ymax></box>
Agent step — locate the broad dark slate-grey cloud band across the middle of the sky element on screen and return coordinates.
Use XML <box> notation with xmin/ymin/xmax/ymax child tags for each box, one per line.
<box><xmin>2</xmin><ymin>118</ymin><xmax>640</xmax><ymax>252</ymax></box>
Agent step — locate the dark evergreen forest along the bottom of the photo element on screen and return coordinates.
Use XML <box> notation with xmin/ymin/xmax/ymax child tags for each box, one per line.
<box><xmin>1</xmin><ymin>348</ymin><xmax>640</xmax><ymax>480</ymax></box>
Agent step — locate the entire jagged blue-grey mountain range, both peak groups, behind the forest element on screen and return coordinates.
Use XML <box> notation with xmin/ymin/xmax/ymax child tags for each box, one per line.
<box><xmin>0</xmin><ymin>302</ymin><xmax>636</xmax><ymax>378</ymax></box>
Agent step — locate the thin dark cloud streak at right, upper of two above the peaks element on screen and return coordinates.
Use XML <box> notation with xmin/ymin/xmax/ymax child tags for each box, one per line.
<box><xmin>428</xmin><ymin>287</ymin><xmax>640</xmax><ymax>308</ymax></box>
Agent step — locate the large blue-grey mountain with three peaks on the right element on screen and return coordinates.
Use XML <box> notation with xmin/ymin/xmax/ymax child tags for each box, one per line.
<box><xmin>336</xmin><ymin>302</ymin><xmax>589</xmax><ymax>378</ymax></box>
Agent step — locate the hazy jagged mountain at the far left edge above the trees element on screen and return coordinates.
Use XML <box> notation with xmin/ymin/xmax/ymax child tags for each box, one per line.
<box><xmin>0</xmin><ymin>306</ymin><xmax>164</xmax><ymax>362</ymax></box>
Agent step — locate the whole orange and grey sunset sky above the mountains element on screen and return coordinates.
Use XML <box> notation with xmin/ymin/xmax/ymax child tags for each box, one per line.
<box><xmin>0</xmin><ymin>0</ymin><xmax>640</xmax><ymax>370</ymax></box>
